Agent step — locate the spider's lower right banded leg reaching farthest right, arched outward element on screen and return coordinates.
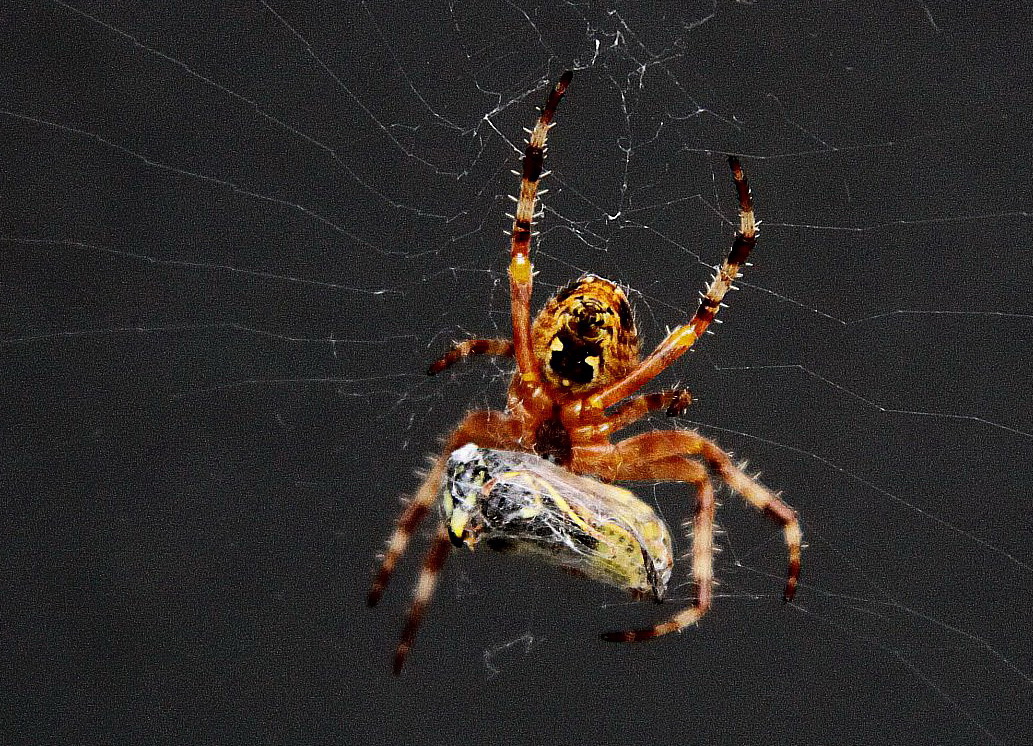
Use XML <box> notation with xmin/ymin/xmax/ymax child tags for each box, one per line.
<box><xmin>599</xmin><ymin>430</ymin><xmax>803</xmax><ymax>601</ymax></box>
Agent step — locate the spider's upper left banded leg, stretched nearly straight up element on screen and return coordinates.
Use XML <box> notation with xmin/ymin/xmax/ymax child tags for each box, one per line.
<box><xmin>509</xmin><ymin>70</ymin><xmax>573</xmax><ymax>382</ymax></box>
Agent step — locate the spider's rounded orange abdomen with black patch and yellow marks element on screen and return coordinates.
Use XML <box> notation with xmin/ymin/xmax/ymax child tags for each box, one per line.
<box><xmin>531</xmin><ymin>275</ymin><xmax>639</xmax><ymax>394</ymax></box>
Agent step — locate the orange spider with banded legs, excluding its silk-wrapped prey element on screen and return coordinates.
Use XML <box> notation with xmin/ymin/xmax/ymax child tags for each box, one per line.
<box><xmin>367</xmin><ymin>71</ymin><xmax>802</xmax><ymax>674</ymax></box>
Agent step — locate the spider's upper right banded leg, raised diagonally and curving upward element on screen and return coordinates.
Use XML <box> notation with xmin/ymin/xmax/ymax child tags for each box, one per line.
<box><xmin>588</xmin><ymin>156</ymin><xmax>757</xmax><ymax>409</ymax></box>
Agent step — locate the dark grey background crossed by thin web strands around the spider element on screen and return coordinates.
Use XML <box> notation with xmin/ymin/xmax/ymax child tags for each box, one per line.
<box><xmin>0</xmin><ymin>0</ymin><xmax>1033</xmax><ymax>744</ymax></box>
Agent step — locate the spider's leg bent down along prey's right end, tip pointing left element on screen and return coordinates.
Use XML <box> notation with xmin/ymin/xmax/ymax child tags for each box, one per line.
<box><xmin>601</xmin><ymin>445</ymin><xmax>717</xmax><ymax>643</ymax></box>
